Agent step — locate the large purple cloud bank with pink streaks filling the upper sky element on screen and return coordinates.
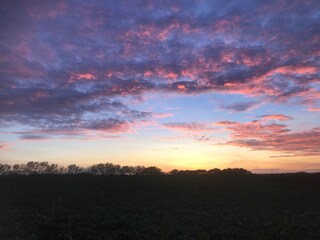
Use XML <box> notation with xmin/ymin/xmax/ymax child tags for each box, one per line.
<box><xmin>0</xmin><ymin>0</ymin><xmax>320</xmax><ymax>135</ymax></box>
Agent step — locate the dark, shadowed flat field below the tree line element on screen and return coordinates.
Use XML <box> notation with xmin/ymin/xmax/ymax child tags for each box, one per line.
<box><xmin>0</xmin><ymin>174</ymin><xmax>320</xmax><ymax>240</ymax></box>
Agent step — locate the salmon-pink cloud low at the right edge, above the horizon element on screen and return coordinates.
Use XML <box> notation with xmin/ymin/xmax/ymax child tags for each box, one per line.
<box><xmin>217</xmin><ymin>119</ymin><xmax>320</xmax><ymax>156</ymax></box>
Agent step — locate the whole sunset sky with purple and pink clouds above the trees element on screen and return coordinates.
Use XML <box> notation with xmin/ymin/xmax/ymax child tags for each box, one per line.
<box><xmin>0</xmin><ymin>0</ymin><xmax>320</xmax><ymax>173</ymax></box>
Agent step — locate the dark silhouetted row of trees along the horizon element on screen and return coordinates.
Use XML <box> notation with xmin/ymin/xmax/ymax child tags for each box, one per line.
<box><xmin>0</xmin><ymin>162</ymin><xmax>251</xmax><ymax>175</ymax></box>
